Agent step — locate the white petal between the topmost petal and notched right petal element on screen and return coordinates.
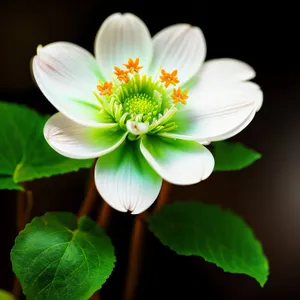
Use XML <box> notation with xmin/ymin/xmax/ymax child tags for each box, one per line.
<box><xmin>151</xmin><ymin>24</ymin><xmax>206</xmax><ymax>84</ymax></box>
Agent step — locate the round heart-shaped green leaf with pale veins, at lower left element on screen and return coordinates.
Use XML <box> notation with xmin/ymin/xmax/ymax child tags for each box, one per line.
<box><xmin>11</xmin><ymin>212</ymin><xmax>115</xmax><ymax>300</ymax></box>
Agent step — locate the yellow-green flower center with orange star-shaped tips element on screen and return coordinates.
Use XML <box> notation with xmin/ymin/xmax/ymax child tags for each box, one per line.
<box><xmin>95</xmin><ymin>58</ymin><xmax>188</xmax><ymax>140</ymax></box>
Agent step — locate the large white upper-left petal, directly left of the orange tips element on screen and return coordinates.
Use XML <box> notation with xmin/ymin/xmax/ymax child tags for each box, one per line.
<box><xmin>32</xmin><ymin>42</ymin><xmax>113</xmax><ymax>127</ymax></box>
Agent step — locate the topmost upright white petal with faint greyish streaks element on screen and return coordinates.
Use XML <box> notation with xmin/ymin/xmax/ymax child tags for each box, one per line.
<box><xmin>95</xmin><ymin>13</ymin><xmax>152</xmax><ymax>78</ymax></box>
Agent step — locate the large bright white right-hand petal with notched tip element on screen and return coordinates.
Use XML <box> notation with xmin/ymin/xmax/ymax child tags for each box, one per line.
<box><xmin>161</xmin><ymin>59</ymin><xmax>263</xmax><ymax>143</ymax></box>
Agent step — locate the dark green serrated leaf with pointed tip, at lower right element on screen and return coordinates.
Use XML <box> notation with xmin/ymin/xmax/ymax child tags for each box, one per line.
<box><xmin>149</xmin><ymin>202</ymin><xmax>269</xmax><ymax>286</ymax></box>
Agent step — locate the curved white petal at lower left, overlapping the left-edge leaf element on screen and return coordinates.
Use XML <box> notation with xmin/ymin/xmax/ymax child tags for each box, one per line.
<box><xmin>44</xmin><ymin>113</ymin><xmax>127</xmax><ymax>159</ymax></box>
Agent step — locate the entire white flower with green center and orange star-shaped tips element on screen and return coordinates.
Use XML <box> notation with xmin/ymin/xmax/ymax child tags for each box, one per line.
<box><xmin>32</xmin><ymin>13</ymin><xmax>263</xmax><ymax>214</ymax></box>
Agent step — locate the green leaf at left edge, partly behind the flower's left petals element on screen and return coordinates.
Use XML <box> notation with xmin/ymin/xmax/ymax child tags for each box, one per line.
<box><xmin>0</xmin><ymin>102</ymin><xmax>92</xmax><ymax>189</ymax></box>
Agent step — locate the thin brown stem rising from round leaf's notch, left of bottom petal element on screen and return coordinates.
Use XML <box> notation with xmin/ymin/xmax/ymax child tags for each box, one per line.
<box><xmin>77</xmin><ymin>159</ymin><xmax>98</xmax><ymax>219</ymax></box>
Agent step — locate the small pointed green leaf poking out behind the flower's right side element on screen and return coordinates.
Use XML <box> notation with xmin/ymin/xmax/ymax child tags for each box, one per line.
<box><xmin>212</xmin><ymin>141</ymin><xmax>261</xmax><ymax>171</ymax></box>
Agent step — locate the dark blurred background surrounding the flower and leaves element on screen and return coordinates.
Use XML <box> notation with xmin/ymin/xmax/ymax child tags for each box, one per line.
<box><xmin>0</xmin><ymin>0</ymin><xmax>300</xmax><ymax>300</ymax></box>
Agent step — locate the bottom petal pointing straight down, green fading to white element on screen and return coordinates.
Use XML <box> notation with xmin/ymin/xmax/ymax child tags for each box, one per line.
<box><xmin>95</xmin><ymin>142</ymin><xmax>162</xmax><ymax>214</ymax></box>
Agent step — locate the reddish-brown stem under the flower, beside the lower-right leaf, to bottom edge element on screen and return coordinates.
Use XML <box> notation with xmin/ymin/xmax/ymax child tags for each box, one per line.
<box><xmin>124</xmin><ymin>181</ymin><xmax>171</xmax><ymax>300</ymax></box>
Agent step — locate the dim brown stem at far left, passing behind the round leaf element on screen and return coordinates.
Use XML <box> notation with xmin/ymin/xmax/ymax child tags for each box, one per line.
<box><xmin>13</xmin><ymin>183</ymin><xmax>33</xmax><ymax>299</ymax></box>
